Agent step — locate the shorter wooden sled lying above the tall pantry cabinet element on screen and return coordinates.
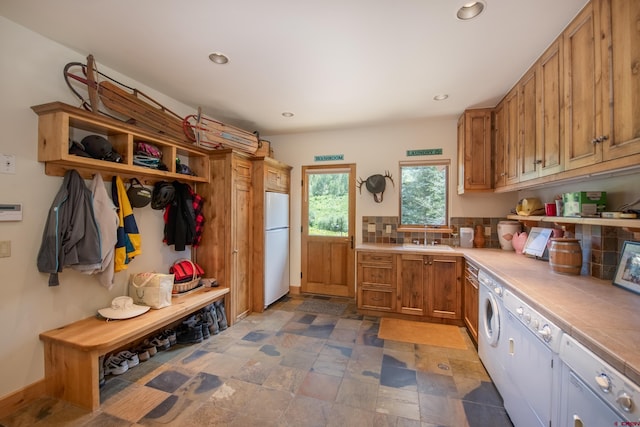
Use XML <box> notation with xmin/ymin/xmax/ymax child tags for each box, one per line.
<box><xmin>182</xmin><ymin>108</ymin><xmax>260</xmax><ymax>154</ymax></box>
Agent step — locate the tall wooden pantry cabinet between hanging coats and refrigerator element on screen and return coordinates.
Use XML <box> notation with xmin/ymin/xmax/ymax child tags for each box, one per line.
<box><xmin>195</xmin><ymin>150</ymin><xmax>253</xmax><ymax>324</ymax></box>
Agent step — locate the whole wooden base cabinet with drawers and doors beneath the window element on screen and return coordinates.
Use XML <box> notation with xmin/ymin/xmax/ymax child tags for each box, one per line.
<box><xmin>357</xmin><ymin>251</ymin><xmax>464</xmax><ymax>325</ymax></box>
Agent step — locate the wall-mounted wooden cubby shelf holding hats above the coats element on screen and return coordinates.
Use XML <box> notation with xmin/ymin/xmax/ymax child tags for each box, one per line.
<box><xmin>31</xmin><ymin>102</ymin><xmax>210</xmax><ymax>184</ymax></box>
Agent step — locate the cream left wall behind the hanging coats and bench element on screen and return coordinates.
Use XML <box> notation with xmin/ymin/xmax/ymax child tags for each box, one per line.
<box><xmin>0</xmin><ymin>17</ymin><xmax>194</xmax><ymax>398</ymax></box>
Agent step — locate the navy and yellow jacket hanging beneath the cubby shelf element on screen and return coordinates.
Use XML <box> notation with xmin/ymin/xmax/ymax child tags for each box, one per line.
<box><xmin>111</xmin><ymin>176</ymin><xmax>142</xmax><ymax>272</ymax></box>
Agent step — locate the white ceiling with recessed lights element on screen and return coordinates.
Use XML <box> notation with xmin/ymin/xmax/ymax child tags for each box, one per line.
<box><xmin>0</xmin><ymin>0</ymin><xmax>587</xmax><ymax>135</ymax></box>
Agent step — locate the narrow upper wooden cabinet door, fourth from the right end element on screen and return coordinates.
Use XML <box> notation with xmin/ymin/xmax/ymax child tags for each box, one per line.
<box><xmin>518</xmin><ymin>67</ymin><xmax>542</xmax><ymax>182</ymax></box>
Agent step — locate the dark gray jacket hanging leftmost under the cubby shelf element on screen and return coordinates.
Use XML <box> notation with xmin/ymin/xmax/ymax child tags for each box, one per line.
<box><xmin>38</xmin><ymin>169</ymin><xmax>101</xmax><ymax>286</ymax></box>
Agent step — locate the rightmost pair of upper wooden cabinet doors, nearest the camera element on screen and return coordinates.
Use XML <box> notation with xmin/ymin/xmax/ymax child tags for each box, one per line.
<box><xmin>564</xmin><ymin>0</ymin><xmax>640</xmax><ymax>169</ymax></box>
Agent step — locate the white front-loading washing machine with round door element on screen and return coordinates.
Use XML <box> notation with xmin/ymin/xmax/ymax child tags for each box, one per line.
<box><xmin>478</xmin><ymin>270</ymin><xmax>512</xmax><ymax>397</ymax></box>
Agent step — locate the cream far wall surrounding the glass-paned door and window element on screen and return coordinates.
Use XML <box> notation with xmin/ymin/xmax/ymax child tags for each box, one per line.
<box><xmin>265</xmin><ymin>121</ymin><xmax>517</xmax><ymax>285</ymax></box>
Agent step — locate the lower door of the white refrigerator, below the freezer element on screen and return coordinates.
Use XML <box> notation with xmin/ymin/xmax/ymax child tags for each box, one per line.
<box><xmin>264</xmin><ymin>228</ymin><xmax>289</xmax><ymax>307</ymax></box>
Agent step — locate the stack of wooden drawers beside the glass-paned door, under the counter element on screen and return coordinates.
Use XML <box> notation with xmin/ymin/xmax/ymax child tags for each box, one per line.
<box><xmin>357</xmin><ymin>252</ymin><xmax>397</xmax><ymax>312</ymax></box>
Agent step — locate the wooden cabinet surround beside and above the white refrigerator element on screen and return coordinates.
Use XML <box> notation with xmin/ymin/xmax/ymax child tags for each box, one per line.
<box><xmin>251</xmin><ymin>157</ymin><xmax>291</xmax><ymax>313</ymax></box>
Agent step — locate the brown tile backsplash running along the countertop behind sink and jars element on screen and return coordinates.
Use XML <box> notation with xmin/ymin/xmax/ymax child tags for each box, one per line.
<box><xmin>362</xmin><ymin>216</ymin><xmax>634</xmax><ymax>280</ymax></box>
